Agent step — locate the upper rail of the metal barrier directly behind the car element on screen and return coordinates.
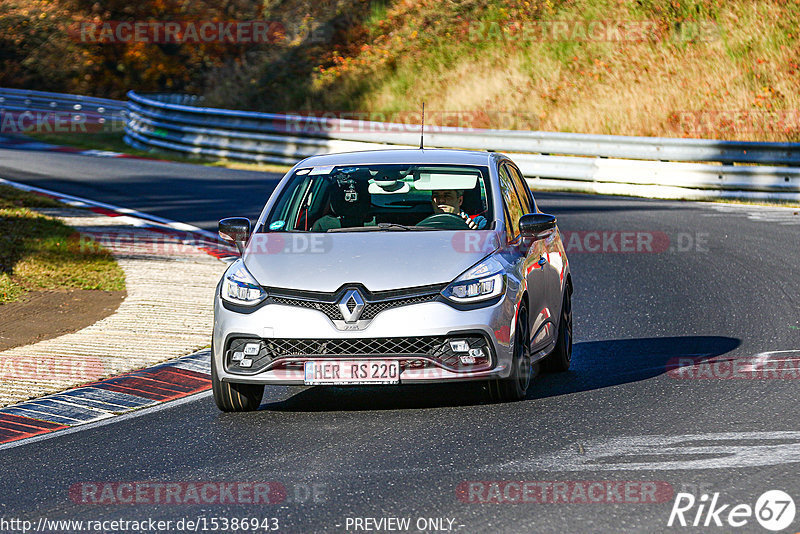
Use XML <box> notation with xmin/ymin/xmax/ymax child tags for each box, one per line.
<box><xmin>123</xmin><ymin>91</ymin><xmax>800</xmax><ymax>165</ymax></box>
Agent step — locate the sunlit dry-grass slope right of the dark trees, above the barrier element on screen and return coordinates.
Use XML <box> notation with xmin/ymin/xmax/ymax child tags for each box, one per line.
<box><xmin>206</xmin><ymin>0</ymin><xmax>800</xmax><ymax>141</ymax></box>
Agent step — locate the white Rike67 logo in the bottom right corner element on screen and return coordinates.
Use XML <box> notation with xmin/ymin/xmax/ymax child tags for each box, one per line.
<box><xmin>667</xmin><ymin>490</ymin><xmax>795</xmax><ymax>532</ymax></box>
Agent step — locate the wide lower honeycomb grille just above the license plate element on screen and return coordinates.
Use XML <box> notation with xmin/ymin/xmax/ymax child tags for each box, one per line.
<box><xmin>226</xmin><ymin>334</ymin><xmax>491</xmax><ymax>374</ymax></box>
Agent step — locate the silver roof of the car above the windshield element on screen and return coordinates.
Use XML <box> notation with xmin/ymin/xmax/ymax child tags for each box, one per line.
<box><xmin>296</xmin><ymin>148</ymin><xmax>495</xmax><ymax>168</ymax></box>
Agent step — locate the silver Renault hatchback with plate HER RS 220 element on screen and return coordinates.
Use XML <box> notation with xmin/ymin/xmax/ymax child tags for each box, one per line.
<box><xmin>211</xmin><ymin>149</ymin><xmax>572</xmax><ymax>411</ymax></box>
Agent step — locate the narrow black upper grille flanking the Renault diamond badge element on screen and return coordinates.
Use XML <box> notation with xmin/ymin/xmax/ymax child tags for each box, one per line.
<box><xmin>267</xmin><ymin>285</ymin><xmax>445</xmax><ymax>321</ymax></box>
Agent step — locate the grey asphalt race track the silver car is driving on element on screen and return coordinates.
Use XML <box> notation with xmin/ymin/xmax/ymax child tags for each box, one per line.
<box><xmin>0</xmin><ymin>151</ymin><xmax>800</xmax><ymax>533</ymax></box>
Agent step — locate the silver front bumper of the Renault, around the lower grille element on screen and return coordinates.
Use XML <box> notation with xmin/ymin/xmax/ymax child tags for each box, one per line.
<box><xmin>212</xmin><ymin>292</ymin><xmax>515</xmax><ymax>385</ymax></box>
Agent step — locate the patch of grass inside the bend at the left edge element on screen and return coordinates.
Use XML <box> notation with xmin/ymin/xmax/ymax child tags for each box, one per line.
<box><xmin>0</xmin><ymin>185</ymin><xmax>125</xmax><ymax>304</ymax></box>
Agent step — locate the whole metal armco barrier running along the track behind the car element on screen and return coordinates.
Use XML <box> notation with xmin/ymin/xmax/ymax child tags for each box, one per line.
<box><xmin>0</xmin><ymin>89</ymin><xmax>800</xmax><ymax>200</ymax></box>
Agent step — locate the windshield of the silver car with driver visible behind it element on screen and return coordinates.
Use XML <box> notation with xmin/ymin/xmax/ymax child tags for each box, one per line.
<box><xmin>260</xmin><ymin>164</ymin><xmax>493</xmax><ymax>232</ymax></box>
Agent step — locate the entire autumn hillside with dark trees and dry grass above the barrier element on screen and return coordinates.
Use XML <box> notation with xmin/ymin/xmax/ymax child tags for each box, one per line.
<box><xmin>6</xmin><ymin>0</ymin><xmax>800</xmax><ymax>141</ymax></box>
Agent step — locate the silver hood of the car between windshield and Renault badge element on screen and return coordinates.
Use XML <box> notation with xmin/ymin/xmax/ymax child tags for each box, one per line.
<box><xmin>244</xmin><ymin>230</ymin><xmax>498</xmax><ymax>292</ymax></box>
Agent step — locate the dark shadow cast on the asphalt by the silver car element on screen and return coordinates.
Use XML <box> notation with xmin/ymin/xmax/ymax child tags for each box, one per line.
<box><xmin>261</xmin><ymin>336</ymin><xmax>740</xmax><ymax>412</ymax></box>
